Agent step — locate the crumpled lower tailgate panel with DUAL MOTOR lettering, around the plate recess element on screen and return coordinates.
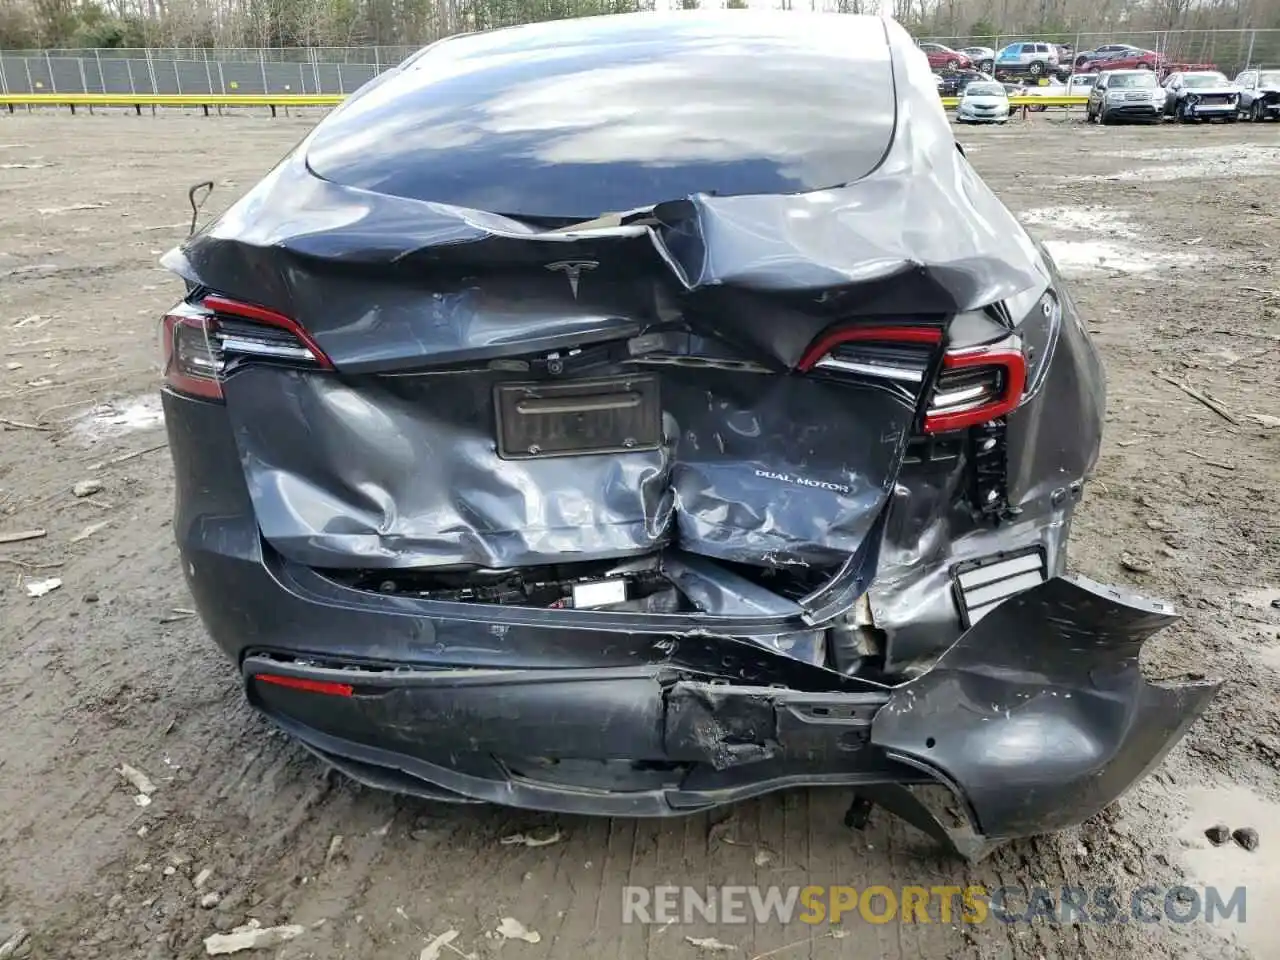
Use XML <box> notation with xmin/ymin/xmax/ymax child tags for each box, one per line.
<box><xmin>225</xmin><ymin>366</ymin><xmax>913</xmax><ymax>567</ymax></box>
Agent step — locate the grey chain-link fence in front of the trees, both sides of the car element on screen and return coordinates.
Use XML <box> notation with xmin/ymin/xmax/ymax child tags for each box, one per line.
<box><xmin>0</xmin><ymin>29</ymin><xmax>1280</xmax><ymax>95</ymax></box>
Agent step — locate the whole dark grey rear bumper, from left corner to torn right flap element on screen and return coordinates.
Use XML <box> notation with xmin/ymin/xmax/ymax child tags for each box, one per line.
<box><xmin>165</xmin><ymin>384</ymin><xmax>1217</xmax><ymax>855</ymax></box>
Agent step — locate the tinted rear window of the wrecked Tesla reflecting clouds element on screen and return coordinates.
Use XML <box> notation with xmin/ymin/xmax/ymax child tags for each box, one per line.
<box><xmin>307</xmin><ymin>10</ymin><xmax>896</xmax><ymax>219</ymax></box>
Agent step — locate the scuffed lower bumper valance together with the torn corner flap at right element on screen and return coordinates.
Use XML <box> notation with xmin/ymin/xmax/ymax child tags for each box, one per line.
<box><xmin>243</xmin><ymin>577</ymin><xmax>1220</xmax><ymax>855</ymax></box>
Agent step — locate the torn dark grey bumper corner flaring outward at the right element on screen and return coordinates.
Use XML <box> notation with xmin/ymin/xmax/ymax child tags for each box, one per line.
<box><xmin>872</xmin><ymin>577</ymin><xmax>1221</xmax><ymax>838</ymax></box>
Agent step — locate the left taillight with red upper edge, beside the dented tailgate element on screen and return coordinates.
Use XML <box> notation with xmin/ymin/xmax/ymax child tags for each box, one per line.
<box><xmin>160</xmin><ymin>294</ymin><xmax>333</xmax><ymax>399</ymax></box>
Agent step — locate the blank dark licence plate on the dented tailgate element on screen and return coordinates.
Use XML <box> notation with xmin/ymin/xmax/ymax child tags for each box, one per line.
<box><xmin>494</xmin><ymin>375</ymin><xmax>662</xmax><ymax>460</ymax></box>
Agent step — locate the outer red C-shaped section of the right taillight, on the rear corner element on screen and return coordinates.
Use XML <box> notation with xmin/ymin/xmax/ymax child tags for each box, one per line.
<box><xmin>924</xmin><ymin>346</ymin><xmax>1027</xmax><ymax>434</ymax></box>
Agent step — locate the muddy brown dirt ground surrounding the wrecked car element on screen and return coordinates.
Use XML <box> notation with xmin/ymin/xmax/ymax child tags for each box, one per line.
<box><xmin>0</xmin><ymin>111</ymin><xmax>1280</xmax><ymax>960</ymax></box>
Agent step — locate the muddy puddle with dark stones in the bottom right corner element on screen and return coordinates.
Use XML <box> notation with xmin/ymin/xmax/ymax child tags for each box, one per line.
<box><xmin>1178</xmin><ymin>785</ymin><xmax>1280</xmax><ymax>957</ymax></box>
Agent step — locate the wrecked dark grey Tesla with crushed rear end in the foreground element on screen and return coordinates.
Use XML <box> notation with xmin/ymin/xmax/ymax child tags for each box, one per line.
<box><xmin>163</xmin><ymin>10</ymin><xmax>1217</xmax><ymax>856</ymax></box>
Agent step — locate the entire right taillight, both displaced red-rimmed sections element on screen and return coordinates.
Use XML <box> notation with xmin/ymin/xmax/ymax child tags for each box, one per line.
<box><xmin>797</xmin><ymin>325</ymin><xmax>1027</xmax><ymax>434</ymax></box>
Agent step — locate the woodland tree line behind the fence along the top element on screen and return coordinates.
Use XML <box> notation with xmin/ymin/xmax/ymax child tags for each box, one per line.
<box><xmin>0</xmin><ymin>0</ymin><xmax>1280</xmax><ymax>49</ymax></box>
